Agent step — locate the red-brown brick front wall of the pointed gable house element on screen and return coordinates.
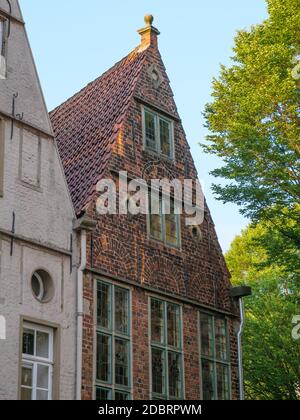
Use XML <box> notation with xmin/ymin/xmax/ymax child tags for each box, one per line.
<box><xmin>83</xmin><ymin>39</ymin><xmax>238</xmax><ymax>399</ymax></box>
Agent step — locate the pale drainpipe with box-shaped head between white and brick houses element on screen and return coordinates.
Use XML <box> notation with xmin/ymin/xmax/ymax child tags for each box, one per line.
<box><xmin>73</xmin><ymin>215</ymin><xmax>96</xmax><ymax>401</ymax></box>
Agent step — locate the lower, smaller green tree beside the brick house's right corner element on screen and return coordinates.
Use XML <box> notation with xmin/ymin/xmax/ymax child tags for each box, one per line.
<box><xmin>226</xmin><ymin>224</ymin><xmax>300</xmax><ymax>400</ymax></box>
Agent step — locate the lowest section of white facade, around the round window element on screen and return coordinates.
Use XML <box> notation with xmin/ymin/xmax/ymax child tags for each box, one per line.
<box><xmin>0</xmin><ymin>235</ymin><xmax>76</xmax><ymax>400</ymax></box>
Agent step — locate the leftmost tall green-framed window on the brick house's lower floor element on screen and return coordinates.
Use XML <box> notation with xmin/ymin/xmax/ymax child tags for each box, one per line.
<box><xmin>96</xmin><ymin>280</ymin><xmax>132</xmax><ymax>401</ymax></box>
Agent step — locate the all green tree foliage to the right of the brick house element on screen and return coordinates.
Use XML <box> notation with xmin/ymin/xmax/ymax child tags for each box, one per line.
<box><xmin>203</xmin><ymin>0</ymin><xmax>300</xmax><ymax>399</ymax></box>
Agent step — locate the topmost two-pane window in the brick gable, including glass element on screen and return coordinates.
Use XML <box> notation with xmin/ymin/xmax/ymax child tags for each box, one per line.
<box><xmin>143</xmin><ymin>108</ymin><xmax>174</xmax><ymax>160</ymax></box>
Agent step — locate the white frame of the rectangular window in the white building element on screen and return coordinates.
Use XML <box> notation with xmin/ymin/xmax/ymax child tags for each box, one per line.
<box><xmin>20</xmin><ymin>323</ymin><xmax>54</xmax><ymax>401</ymax></box>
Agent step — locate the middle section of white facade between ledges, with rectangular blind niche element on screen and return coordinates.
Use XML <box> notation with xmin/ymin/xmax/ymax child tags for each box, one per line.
<box><xmin>0</xmin><ymin>119</ymin><xmax>74</xmax><ymax>249</ymax></box>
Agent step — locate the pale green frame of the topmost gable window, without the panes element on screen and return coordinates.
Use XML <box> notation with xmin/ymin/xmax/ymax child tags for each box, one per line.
<box><xmin>142</xmin><ymin>106</ymin><xmax>175</xmax><ymax>161</ymax></box>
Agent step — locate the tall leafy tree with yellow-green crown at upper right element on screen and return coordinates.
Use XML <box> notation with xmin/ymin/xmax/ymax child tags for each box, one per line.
<box><xmin>203</xmin><ymin>0</ymin><xmax>300</xmax><ymax>249</ymax></box>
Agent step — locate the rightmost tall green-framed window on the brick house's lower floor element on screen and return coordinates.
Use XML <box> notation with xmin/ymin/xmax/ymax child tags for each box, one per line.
<box><xmin>200</xmin><ymin>313</ymin><xmax>231</xmax><ymax>401</ymax></box>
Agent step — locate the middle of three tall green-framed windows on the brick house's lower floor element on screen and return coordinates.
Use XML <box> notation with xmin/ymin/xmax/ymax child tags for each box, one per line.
<box><xmin>149</xmin><ymin>298</ymin><xmax>184</xmax><ymax>400</ymax></box>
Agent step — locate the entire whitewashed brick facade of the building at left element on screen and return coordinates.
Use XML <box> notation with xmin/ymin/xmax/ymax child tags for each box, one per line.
<box><xmin>0</xmin><ymin>0</ymin><xmax>76</xmax><ymax>400</ymax></box>
